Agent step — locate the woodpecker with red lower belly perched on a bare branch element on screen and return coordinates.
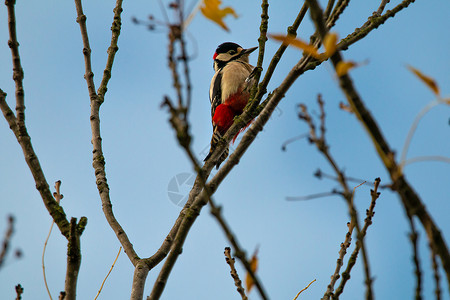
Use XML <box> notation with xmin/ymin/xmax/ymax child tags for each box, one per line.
<box><xmin>205</xmin><ymin>42</ymin><xmax>258</xmax><ymax>169</ymax></box>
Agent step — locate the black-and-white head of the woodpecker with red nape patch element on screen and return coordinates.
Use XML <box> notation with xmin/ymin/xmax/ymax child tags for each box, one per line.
<box><xmin>213</xmin><ymin>42</ymin><xmax>258</xmax><ymax>71</ymax></box>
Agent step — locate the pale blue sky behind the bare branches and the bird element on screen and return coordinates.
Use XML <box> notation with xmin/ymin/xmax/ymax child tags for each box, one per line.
<box><xmin>0</xmin><ymin>0</ymin><xmax>450</xmax><ymax>299</ymax></box>
